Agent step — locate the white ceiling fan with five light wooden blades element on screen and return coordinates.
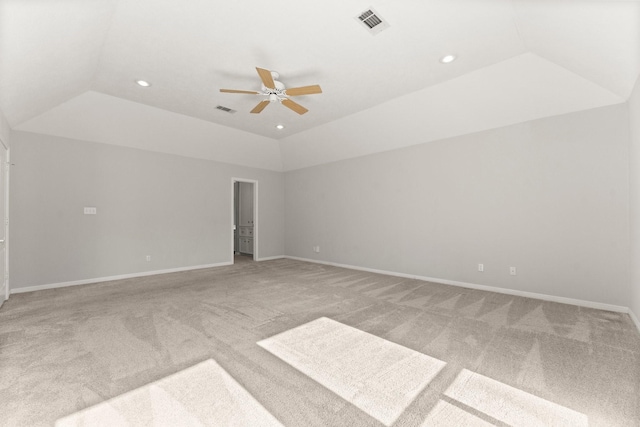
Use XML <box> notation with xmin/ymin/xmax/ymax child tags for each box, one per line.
<box><xmin>220</xmin><ymin>67</ymin><xmax>322</xmax><ymax>114</ymax></box>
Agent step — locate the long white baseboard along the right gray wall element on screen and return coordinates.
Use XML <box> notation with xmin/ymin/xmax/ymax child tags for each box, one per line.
<box><xmin>284</xmin><ymin>255</ymin><xmax>640</xmax><ymax>314</ymax></box>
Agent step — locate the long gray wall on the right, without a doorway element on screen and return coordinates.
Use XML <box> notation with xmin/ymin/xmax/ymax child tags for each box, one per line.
<box><xmin>285</xmin><ymin>104</ymin><xmax>630</xmax><ymax>306</ymax></box>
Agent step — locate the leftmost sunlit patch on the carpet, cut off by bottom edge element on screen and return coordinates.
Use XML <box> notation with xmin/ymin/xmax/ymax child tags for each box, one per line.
<box><xmin>56</xmin><ymin>359</ymin><xmax>282</xmax><ymax>427</ymax></box>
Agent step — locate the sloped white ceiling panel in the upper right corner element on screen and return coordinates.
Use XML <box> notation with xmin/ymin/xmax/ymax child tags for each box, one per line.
<box><xmin>512</xmin><ymin>0</ymin><xmax>640</xmax><ymax>99</ymax></box>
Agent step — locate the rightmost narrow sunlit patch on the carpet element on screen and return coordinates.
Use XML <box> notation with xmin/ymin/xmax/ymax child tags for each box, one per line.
<box><xmin>444</xmin><ymin>369</ymin><xmax>589</xmax><ymax>427</ymax></box>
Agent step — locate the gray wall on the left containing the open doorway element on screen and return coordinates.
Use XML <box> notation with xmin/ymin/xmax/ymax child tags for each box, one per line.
<box><xmin>10</xmin><ymin>132</ymin><xmax>284</xmax><ymax>289</ymax></box>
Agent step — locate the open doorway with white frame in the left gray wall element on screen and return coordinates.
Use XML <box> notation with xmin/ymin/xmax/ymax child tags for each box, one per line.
<box><xmin>231</xmin><ymin>178</ymin><xmax>258</xmax><ymax>263</ymax></box>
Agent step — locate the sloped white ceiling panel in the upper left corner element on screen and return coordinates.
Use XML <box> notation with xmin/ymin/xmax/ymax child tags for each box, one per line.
<box><xmin>0</xmin><ymin>0</ymin><xmax>118</xmax><ymax>128</ymax></box>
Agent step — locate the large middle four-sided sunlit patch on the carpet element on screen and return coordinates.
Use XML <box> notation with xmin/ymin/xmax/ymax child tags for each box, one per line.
<box><xmin>258</xmin><ymin>317</ymin><xmax>446</xmax><ymax>426</ymax></box>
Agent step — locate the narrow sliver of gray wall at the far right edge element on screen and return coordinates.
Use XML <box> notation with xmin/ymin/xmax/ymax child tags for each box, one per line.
<box><xmin>627</xmin><ymin>78</ymin><xmax>640</xmax><ymax>319</ymax></box>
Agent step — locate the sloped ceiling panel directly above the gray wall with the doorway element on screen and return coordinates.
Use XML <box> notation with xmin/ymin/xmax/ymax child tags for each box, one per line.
<box><xmin>14</xmin><ymin>91</ymin><xmax>282</xmax><ymax>172</ymax></box>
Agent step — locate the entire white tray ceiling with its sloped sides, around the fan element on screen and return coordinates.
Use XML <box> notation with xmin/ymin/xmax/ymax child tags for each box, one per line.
<box><xmin>0</xmin><ymin>0</ymin><xmax>640</xmax><ymax>170</ymax></box>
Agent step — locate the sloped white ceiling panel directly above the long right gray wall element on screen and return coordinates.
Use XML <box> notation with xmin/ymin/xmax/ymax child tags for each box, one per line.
<box><xmin>280</xmin><ymin>53</ymin><xmax>625</xmax><ymax>171</ymax></box>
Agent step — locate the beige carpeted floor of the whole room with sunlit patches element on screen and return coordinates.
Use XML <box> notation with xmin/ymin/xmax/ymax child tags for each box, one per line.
<box><xmin>0</xmin><ymin>259</ymin><xmax>640</xmax><ymax>427</ymax></box>
